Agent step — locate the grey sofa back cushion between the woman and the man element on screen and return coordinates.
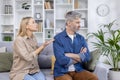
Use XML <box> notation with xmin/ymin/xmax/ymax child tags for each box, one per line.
<box><xmin>38</xmin><ymin>43</ymin><xmax>53</xmax><ymax>69</ymax></box>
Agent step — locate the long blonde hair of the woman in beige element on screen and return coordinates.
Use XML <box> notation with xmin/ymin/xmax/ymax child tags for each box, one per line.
<box><xmin>18</xmin><ymin>17</ymin><xmax>32</xmax><ymax>37</ymax></box>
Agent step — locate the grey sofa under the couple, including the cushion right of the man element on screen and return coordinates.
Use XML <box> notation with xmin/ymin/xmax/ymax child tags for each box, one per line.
<box><xmin>0</xmin><ymin>42</ymin><xmax>107</xmax><ymax>80</ymax></box>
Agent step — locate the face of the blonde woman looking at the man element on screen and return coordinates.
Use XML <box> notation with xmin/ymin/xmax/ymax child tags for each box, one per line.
<box><xmin>27</xmin><ymin>18</ymin><xmax>38</xmax><ymax>32</ymax></box>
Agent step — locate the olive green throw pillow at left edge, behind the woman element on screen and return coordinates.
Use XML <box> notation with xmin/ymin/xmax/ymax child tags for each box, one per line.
<box><xmin>0</xmin><ymin>52</ymin><xmax>13</xmax><ymax>72</ymax></box>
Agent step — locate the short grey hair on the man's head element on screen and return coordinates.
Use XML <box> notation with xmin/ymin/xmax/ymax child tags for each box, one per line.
<box><xmin>65</xmin><ymin>11</ymin><xmax>81</xmax><ymax>23</ymax></box>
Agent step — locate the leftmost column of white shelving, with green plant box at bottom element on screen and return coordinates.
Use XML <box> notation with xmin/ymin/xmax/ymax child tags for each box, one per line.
<box><xmin>0</xmin><ymin>0</ymin><xmax>14</xmax><ymax>41</ymax></box>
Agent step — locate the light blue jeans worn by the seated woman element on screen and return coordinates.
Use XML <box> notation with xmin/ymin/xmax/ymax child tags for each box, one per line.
<box><xmin>24</xmin><ymin>71</ymin><xmax>46</xmax><ymax>80</ymax></box>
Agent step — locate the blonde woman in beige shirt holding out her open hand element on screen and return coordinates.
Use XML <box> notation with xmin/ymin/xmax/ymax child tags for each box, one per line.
<box><xmin>10</xmin><ymin>17</ymin><xmax>54</xmax><ymax>80</ymax></box>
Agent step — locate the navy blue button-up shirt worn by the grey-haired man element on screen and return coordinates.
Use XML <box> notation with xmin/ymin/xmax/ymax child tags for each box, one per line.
<box><xmin>53</xmin><ymin>29</ymin><xmax>91</xmax><ymax>77</ymax></box>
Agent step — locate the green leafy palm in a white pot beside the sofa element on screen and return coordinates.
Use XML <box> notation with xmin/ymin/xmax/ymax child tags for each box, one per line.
<box><xmin>90</xmin><ymin>20</ymin><xmax>120</xmax><ymax>80</ymax></box>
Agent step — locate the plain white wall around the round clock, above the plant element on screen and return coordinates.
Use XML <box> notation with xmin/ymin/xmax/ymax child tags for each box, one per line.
<box><xmin>88</xmin><ymin>0</ymin><xmax>120</xmax><ymax>51</ymax></box>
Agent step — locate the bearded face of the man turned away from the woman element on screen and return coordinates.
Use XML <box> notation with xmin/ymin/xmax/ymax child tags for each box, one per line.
<box><xmin>69</xmin><ymin>18</ymin><xmax>80</xmax><ymax>32</ymax></box>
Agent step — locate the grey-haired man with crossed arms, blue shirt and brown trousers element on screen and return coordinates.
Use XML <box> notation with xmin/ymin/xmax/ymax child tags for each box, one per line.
<box><xmin>53</xmin><ymin>11</ymin><xmax>98</xmax><ymax>80</ymax></box>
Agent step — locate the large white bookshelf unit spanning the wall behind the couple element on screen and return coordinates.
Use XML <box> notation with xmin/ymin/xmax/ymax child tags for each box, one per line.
<box><xmin>0</xmin><ymin>0</ymin><xmax>88</xmax><ymax>43</ymax></box>
